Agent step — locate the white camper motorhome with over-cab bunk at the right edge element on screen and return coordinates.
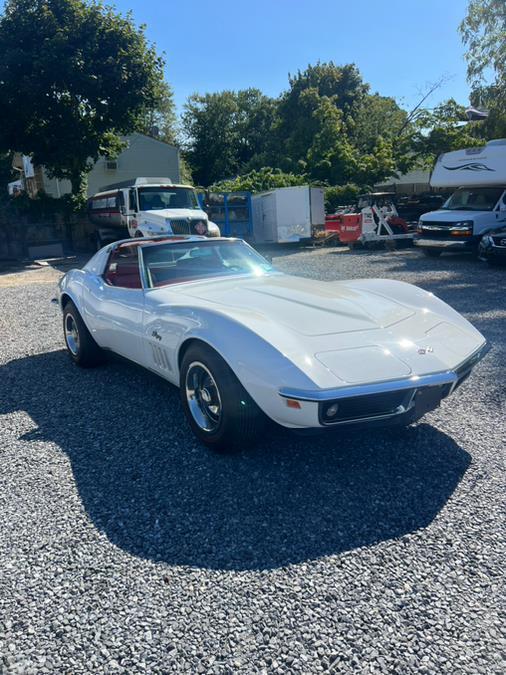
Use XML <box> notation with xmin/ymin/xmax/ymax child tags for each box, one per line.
<box><xmin>414</xmin><ymin>139</ymin><xmax>506</xmax><ymax>256</ymax></box>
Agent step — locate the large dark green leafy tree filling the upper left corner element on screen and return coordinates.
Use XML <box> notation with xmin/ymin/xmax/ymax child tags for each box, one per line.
<box><xmin>0</xmin><ymin>0</ymin><xmax>163</xmax><ymax>195</ymax></box>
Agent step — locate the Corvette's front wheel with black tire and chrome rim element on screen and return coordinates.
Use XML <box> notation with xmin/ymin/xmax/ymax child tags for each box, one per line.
<box><xmin>180</xmin><ymin>344</ymin><xmax>265</xmax><ymax>452</ymax></box>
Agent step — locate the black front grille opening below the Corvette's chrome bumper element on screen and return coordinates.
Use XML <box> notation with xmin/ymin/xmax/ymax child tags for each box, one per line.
<box><xmin>320</xmin><ymin>389</ymin><xmax>414</xmax><ymax>424</ymax></box>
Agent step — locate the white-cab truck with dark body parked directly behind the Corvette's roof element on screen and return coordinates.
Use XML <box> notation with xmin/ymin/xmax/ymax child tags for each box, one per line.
<box><xmin>88</xmin><ymin>178</ymin><xmax>220</xmax><ymax>248</ymax></box>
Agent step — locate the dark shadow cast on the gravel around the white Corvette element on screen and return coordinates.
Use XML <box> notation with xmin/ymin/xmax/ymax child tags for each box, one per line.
<box><xmin>0</xmin><ymin>351</ymin><xmax>470</xmax><ymax>570</ymax></box>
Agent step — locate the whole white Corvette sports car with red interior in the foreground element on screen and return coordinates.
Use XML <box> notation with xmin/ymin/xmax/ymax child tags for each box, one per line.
<box><xmin>59</xmin><ymin>237</ymin><xmax>487</xmax><ymax>450</ymax></box>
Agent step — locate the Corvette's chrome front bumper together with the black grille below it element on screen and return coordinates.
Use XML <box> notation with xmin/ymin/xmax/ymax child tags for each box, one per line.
<box><xmin>279</xmin><ymin>342</ymin><xmax>490</xmax><ymax>427</ymax></box>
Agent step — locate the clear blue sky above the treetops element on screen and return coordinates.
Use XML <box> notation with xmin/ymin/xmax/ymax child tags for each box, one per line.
<box><xmin>111</xmin><ymin>0</ymin><xmax>469</xmax><ymax>113</ymax></box>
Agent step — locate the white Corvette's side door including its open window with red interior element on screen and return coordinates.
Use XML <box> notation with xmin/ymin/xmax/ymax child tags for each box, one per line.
<box><xmin>83</xmin><ymin>244</ymin><xmax>144</xmax><ymax>363</ymax></box>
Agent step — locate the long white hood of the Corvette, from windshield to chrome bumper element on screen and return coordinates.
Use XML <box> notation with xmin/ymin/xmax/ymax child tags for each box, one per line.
<box><xmin>156</xmin><ymin>274</ymin><xmax>485</xmax><ymax>387</ymax></box>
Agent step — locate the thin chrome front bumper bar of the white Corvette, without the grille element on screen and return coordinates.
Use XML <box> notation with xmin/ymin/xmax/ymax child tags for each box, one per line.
<box><xmin>278</xmin><ymin>342</ymin><xmax>490</xmax><ymax>402</ymax></box>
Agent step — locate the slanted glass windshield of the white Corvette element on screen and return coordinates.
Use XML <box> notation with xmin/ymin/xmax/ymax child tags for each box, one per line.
<box><xmin>142</xmin><ymin>241</ymin><xmax>272</xmax><ymax>288</ymax></box>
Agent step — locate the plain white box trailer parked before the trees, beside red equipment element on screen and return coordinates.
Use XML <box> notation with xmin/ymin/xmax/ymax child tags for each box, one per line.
<box><xmin>251</xmin><ymin>185</ymin><xmax>325</xmax><ymax>244</ymax></box>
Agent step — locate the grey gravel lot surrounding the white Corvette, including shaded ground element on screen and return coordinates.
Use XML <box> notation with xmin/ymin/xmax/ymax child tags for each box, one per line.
<box><xmin>0</xmin><ymin>249</ymin><xmax>506</xmax><ymax>675</ymax></box>
